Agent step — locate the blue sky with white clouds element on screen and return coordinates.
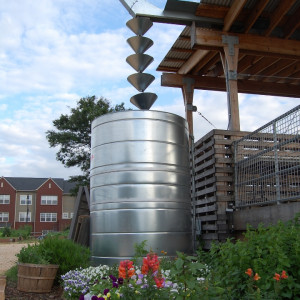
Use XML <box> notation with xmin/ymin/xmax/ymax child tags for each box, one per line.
<box><xmin>0</xmin><ymin>0</ymin><xmax>299</xmax><ymax>179</ymax></box>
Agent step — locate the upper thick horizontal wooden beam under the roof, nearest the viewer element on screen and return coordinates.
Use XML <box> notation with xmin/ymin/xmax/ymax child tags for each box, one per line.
<box><xmin>194</xmin><ymin>27</ymin><xmax>300</xmax><ymax>57</ymax></box>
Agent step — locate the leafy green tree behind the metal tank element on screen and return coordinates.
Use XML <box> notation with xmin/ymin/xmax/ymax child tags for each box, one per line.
<box><xmin>46</xmin><ymin>96</ymin><xmax>125</xmax><ymax>190</ymax></box>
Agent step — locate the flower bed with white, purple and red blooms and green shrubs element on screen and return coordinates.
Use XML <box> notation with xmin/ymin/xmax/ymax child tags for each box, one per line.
<box><xmin>63</xmin><ymin>216</ymin><xmax>300</xmax><ymax>300</ymax></box>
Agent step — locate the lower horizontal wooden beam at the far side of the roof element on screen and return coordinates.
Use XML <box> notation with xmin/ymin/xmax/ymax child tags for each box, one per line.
<box><xmin>161</xmin><ymin>73</ymin><xmax>300</xmax><ymax>98</ymax></box>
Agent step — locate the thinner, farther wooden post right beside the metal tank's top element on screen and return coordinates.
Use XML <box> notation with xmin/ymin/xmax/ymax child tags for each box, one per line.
<box><xmin>182</xmin><ymin>77</ymin><xmax>195</xmax><ymax>136</ymax></box>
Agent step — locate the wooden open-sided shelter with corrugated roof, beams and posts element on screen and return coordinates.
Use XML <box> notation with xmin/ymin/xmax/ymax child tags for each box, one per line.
<box><xmin>157</xmin><ymin>0</ymin><xmax>300</xmax><ymax>134</ymax></box>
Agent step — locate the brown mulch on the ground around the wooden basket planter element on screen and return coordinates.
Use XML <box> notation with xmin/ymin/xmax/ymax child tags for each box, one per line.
<box><xmin>5</xmin><ymin>281</ymin><xmax>64</xmax><ymax>300</ymax></box>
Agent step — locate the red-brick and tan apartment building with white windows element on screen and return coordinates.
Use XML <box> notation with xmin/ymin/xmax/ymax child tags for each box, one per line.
<box><xmin>0</xmin><ymin>177</ymin><xmax>76</xmax><ymax>235</ymax></box>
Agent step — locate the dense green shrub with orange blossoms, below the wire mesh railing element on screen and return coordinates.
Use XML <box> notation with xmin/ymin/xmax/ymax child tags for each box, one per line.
<box><xmin>199</xmin><ymin>214</ymin><xmax>300</xmax><ymax>299</ymax></box>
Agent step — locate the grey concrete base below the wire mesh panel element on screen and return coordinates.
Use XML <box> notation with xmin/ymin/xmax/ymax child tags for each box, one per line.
<box><xmin>233</xmin><ymin>201</ymin><xmax>300</xmax><ymax>231</ymax></box>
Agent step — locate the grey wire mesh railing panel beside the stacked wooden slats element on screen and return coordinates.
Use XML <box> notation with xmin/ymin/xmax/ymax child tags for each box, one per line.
<box><xmin>234</xmin><ymin>105</ymin><xmax>300</xmax><ymax>207</ymax></box>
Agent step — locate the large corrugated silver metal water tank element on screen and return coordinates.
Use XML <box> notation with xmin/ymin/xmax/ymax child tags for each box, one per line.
<box><xmin>90</xmin><ymin>110</ymin><xmax>192</xmax><ymax>265</ymax></box>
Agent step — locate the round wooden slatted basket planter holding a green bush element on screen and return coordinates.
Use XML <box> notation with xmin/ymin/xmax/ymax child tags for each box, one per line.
<box><xmin>17</xmin><ymin>263</ymin><xmax>59</xmax><ymax>293</ymax></box>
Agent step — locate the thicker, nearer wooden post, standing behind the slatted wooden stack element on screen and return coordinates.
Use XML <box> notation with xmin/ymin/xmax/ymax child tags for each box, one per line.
<box><xmin>221</xmin><ymin>35</ymin><xmax>240</xmax><ymax>131</ymax></box>
